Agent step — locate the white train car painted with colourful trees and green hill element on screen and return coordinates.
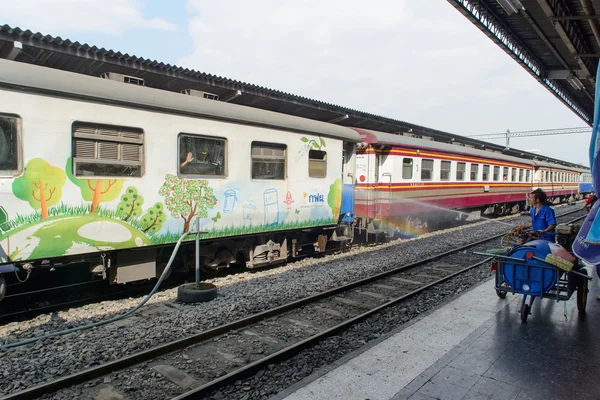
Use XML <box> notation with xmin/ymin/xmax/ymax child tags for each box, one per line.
<box><xmin>0</xmin><ymin>60</ymin><xmax>361</xmax><ymax>294</ymax></box>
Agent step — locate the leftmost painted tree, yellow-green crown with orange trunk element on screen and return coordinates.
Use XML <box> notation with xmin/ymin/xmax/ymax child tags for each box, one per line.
<box><xmin>12</xmin><ymin>158</ymin><xmax>67</xmax><ymax>218</ymax></box>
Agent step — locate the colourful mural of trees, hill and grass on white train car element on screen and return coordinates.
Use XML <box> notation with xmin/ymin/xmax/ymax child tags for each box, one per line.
<box><xmin>0</xmin><ymin>137</ymin><xmax>342</xmax><ymax>263</ymax></box>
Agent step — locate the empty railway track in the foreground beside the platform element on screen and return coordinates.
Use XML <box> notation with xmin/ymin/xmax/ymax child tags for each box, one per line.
<box><xmin>3</xmin><ymin>210</ymin><xmax>583</xmax><ymax>399</ymax></box>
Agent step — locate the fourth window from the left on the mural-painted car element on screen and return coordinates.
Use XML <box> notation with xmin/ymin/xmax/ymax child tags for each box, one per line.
<box><xmin>251</xmin><ymin>142</ymin><xmax>287</xmax><ymax>180</ymax></box>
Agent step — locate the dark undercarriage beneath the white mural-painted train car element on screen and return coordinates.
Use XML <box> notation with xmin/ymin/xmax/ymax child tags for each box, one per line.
<box><xmin>0</xmin><ymin>224</ymin><xmax>353</xmax><ymax>300</ymax></box>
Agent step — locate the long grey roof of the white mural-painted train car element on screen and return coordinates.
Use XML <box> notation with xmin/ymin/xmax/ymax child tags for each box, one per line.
<box><xmin>0</xmin><ymin>59</ymin><xmax>362</xmax><ymax>143</ymax></box>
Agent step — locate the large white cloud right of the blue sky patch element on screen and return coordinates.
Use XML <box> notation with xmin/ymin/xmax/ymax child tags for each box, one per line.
<box><xmin>179</xmin><ymin>0</ymin><xmax>587</xmax><ymax>163</ymax></box>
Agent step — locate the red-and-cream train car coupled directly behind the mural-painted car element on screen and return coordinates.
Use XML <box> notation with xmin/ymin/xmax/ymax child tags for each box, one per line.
<box><xmin>355</xmin><ymin>129</ymin><xmax>535</xmax><ymax>236</ymax></box>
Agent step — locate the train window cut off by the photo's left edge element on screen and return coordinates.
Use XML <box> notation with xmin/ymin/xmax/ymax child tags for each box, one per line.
<box><xmin>0</xmin><ymin>115</ymin><xmax>22</xmax><ymax>176</ymax></box>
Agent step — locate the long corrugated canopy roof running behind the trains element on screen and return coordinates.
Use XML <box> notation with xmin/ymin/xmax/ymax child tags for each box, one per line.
<box><xmin>0</xmin><ymin>25</ymin><xmax>585</xmax><ymax>168</ymax></box>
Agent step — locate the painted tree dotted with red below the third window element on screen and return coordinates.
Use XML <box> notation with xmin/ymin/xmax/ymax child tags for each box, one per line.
<box><xmin>158</xmin><ymin>174</ymin><xmax>217</xmax><ymax>232</ymax></box>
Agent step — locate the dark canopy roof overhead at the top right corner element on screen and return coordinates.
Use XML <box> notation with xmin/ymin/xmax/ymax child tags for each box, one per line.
<box><xmin>448</xmin><ymin>0</ymin><xmax>600</xmax><ymax>126</ymax></box>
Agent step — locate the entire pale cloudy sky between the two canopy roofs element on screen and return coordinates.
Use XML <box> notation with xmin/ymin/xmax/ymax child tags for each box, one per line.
<box><xmin>0</xmin><ymin>0</ymin><xmax>590</xmax><ymax>166</ymax></box>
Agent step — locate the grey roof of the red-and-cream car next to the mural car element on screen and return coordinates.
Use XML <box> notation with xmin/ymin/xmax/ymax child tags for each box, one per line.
<box><xmin>355</xmin><ymin>128</ymin><xmax>536</xmax><ymax>168</ymax></box>
